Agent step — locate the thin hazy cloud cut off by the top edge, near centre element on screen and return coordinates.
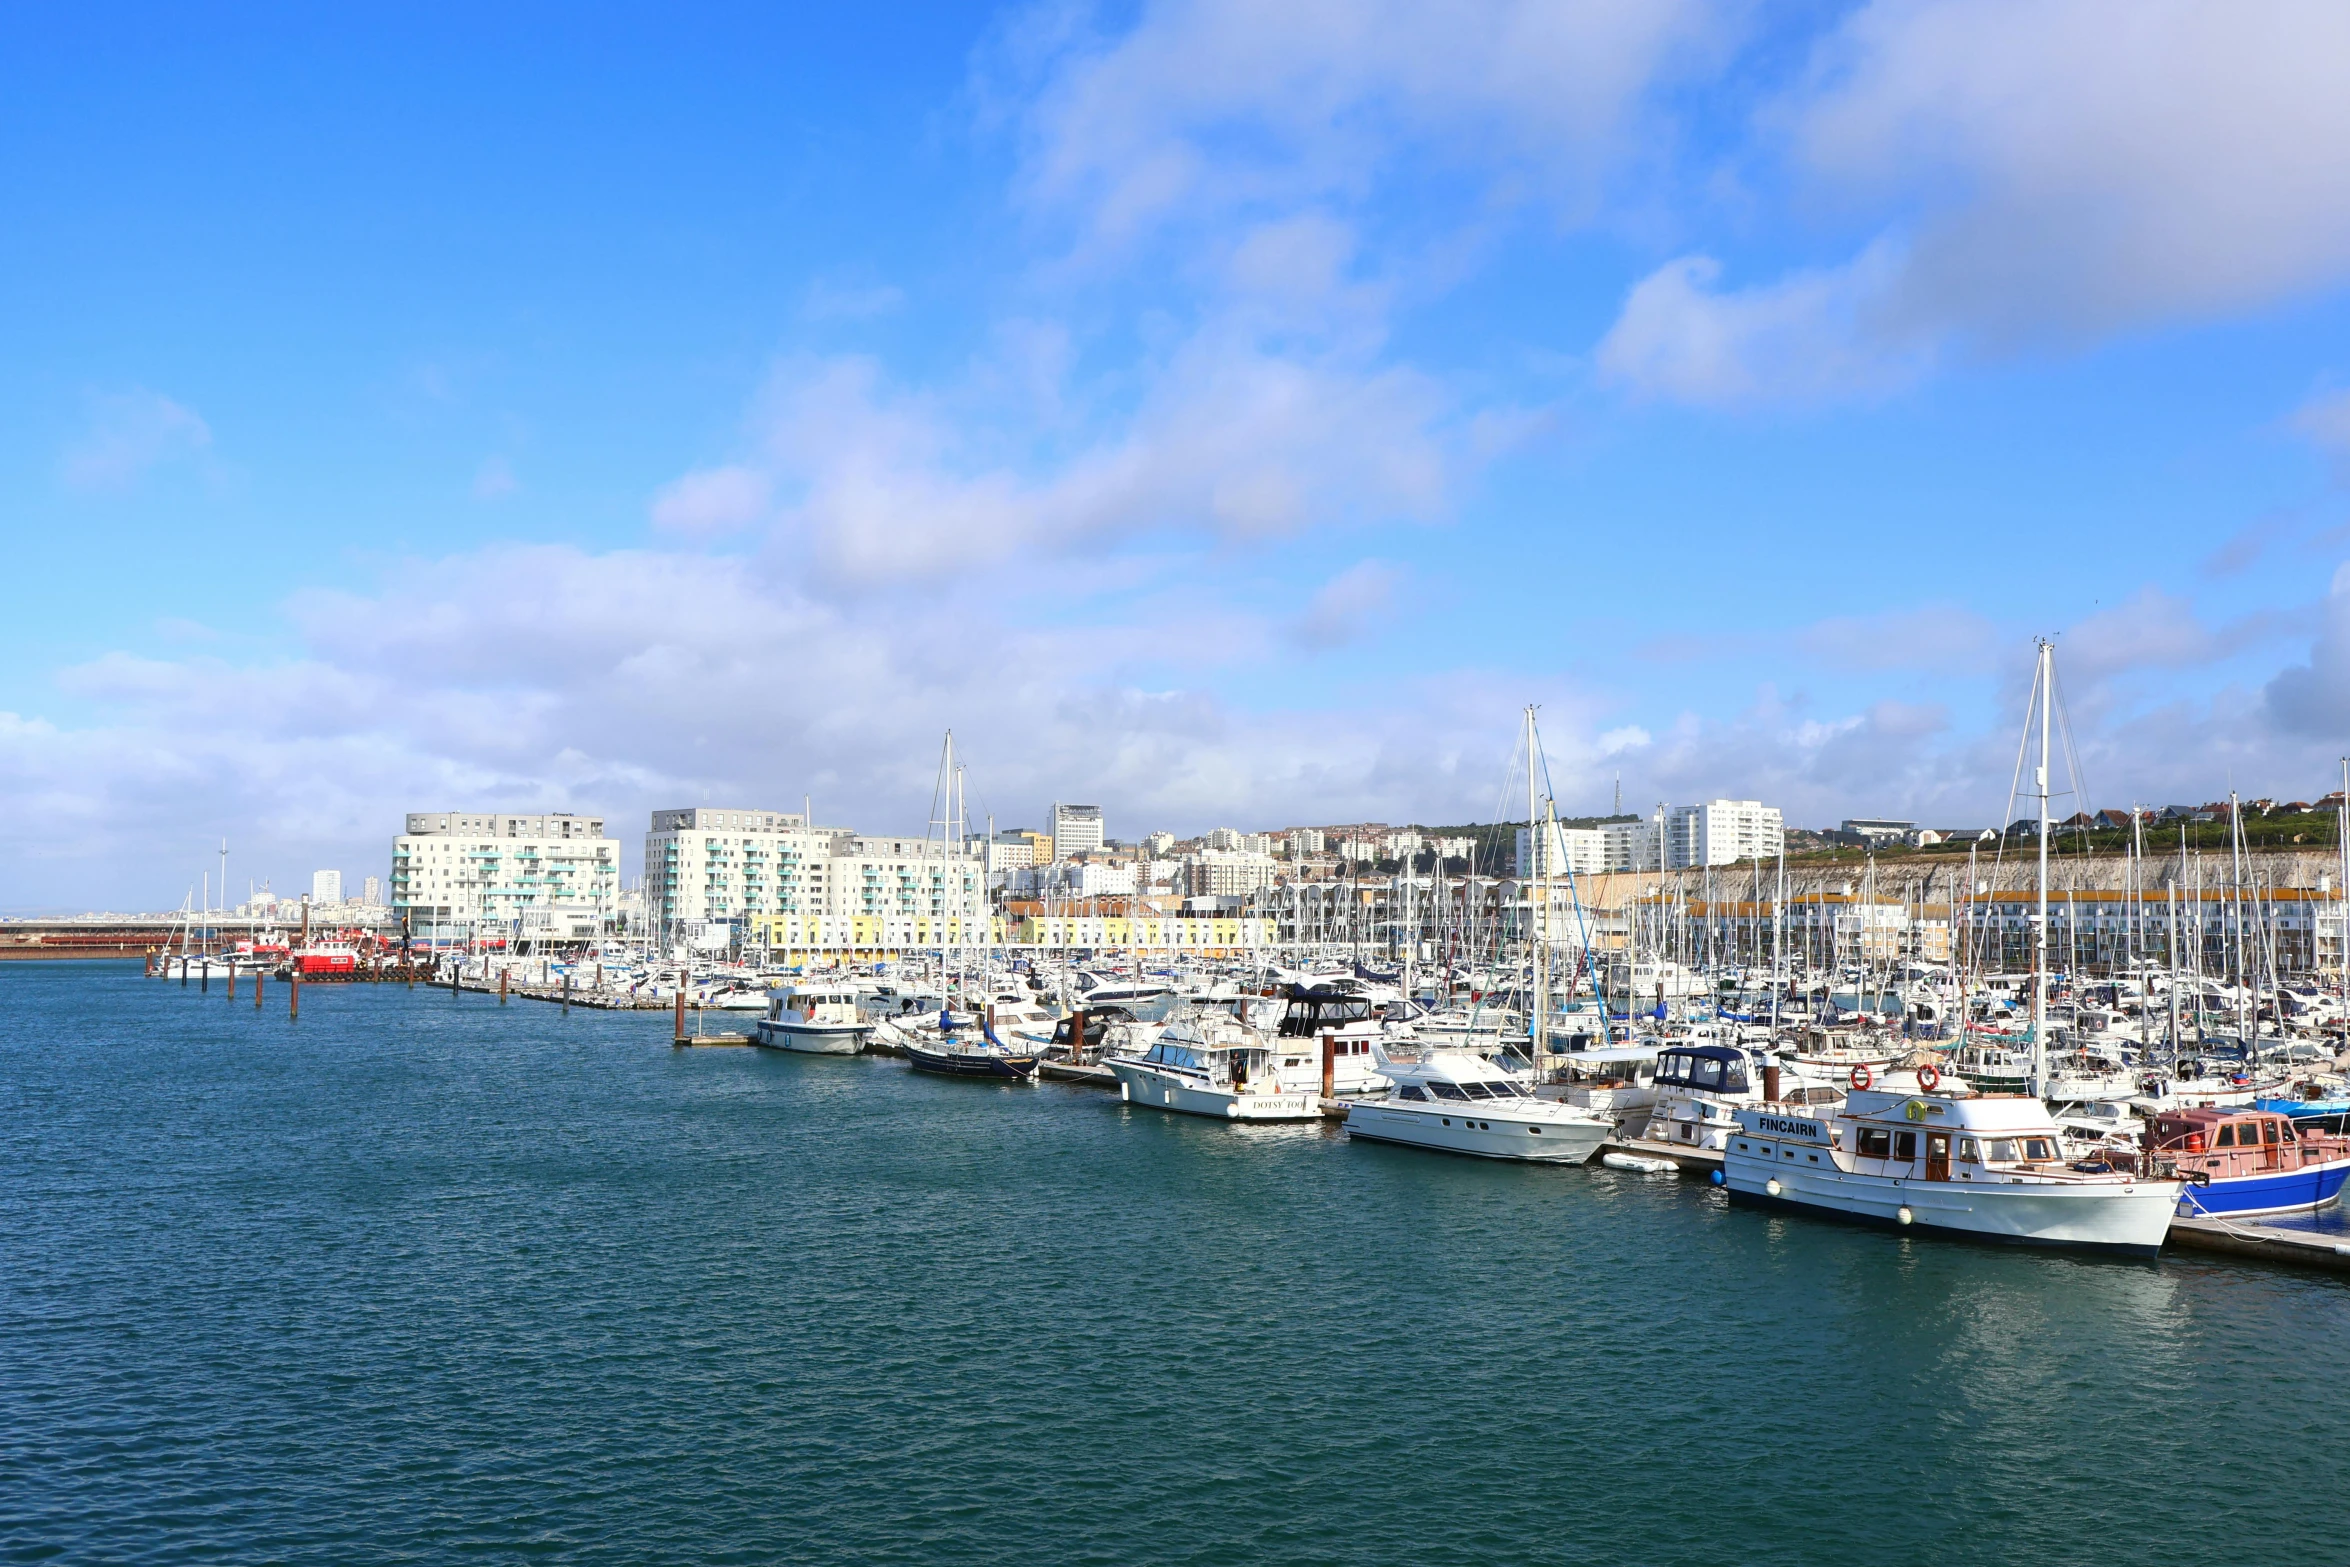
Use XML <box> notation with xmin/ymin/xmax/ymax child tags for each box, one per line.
<box><xmin>1015</xmin><ymin>0</ymin><xmax>1734</xmax><ymax>244</ymax></box>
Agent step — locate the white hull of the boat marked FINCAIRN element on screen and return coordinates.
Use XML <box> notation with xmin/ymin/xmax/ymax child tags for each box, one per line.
<box><xmin>1723</xmin><ymin>1132</ymin><xmax>2178</xmax><ymax>1257</ymax></box>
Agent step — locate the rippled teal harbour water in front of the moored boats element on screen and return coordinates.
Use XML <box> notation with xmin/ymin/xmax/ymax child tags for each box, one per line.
<box><xmin>0</xmin><ymin>963</ymin><xmax>2350</xmax><ymax>1567</ymax></box>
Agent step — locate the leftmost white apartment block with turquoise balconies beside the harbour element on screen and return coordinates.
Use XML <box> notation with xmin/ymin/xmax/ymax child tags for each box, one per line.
<box><xmin>394</xmin><ymin>811</ymin><xmax>620</xmax><ymax>942</ymax></box>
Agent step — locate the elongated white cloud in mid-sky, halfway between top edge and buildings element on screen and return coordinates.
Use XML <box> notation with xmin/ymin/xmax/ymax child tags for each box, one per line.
<box><xmin>719</xmin><ymin>331</ymin><xmax>1464</xmax><ymax>585</ymax></box>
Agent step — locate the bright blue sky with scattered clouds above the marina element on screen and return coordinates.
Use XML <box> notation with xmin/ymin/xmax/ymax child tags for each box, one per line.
<box><xmin>0</xmin><ymin>0</ymin><xmax>2350</xmax><ymax>912</ymax></box>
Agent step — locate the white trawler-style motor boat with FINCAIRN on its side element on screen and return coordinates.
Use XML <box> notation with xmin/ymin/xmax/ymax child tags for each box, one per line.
<box><xmin>1723</xmin><ymin>1083</ymin><xmax>2181</xmax><ymax>1257</ymax></box>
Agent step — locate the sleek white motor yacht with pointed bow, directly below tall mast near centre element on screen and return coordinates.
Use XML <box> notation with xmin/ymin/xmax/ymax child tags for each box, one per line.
<box><xmin>1347</xmin><ymin>1050</ymin><xmax>1614</xmax><ymax>1165</ymax></box>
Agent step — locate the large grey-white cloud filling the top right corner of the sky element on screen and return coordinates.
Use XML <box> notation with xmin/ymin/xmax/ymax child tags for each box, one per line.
<box><xmin>1786</xmin><ymin>0</ymin><xmax>2350</xmax><ymax>341</ymax></box>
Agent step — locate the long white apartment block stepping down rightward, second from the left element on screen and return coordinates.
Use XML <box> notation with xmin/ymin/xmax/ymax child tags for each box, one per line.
<box><xmin>644</xmin><ymin>806</ymin><xmax>987</xmax><ymax>933</ymax></box>
